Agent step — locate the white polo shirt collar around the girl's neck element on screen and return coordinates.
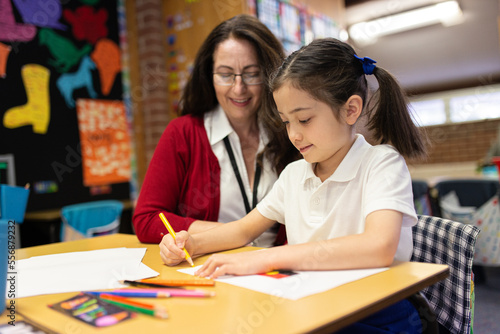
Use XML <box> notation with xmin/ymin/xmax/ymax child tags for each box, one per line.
<box><xmin>302</xmin><ymin>134</ymin><xmax>371</xmax><ymax>184</ymax></box>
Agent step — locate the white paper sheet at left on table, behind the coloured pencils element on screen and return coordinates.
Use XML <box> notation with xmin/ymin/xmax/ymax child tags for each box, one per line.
<box><xmin>11</xmin><ymin>247</ymin><xmax>159</xmax><ymax>298</ymax></box>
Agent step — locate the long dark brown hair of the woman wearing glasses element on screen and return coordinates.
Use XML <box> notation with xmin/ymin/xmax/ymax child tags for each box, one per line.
<box><xmin>179</xmin><ymin>14</ymin><xmax>298</xmax><ymax>172</ymax></box>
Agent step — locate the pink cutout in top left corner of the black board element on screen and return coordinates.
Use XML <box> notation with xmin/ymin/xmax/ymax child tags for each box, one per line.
<box><xmin>0</xmin><ymin>0</ymin><xmax>36</xmax><ymax>42</ymax></box>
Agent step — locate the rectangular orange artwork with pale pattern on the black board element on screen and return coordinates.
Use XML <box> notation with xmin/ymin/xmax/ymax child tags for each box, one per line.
<box><xmin>76</xmin><ymin>99</ymin><xmax>131</xmax><ymax>187</ymax></box>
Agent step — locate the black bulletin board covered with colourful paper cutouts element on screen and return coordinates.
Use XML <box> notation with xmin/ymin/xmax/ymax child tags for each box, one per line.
<box><xmin>0</xmin><ymin>0</ymin><xmax>131</xmax><ymax>211</ymax></box>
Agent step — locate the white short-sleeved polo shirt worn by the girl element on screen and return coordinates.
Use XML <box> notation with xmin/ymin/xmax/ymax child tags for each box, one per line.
<box><xmin>257</xmin><ymin>134</ymin><xmax>417</xmax><ymax>261</ymax></box>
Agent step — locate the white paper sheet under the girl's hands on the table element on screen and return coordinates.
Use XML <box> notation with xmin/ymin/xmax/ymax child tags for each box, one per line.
<box><xmin>178</xmin><ymin>266</ymin><xmax>389</xmax><ymax>300</ymax></box>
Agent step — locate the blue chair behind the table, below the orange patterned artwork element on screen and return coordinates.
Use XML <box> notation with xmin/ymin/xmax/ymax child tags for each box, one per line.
<box><xmin>61</xmin><ymin>200</ymin><xmax>123</xmax><ymax>241</ymax></box>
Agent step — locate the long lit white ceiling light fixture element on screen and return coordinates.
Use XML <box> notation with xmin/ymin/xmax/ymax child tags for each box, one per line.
<box><xmin>349</xmin><ymin>1</ymin><xmax>463</xmax><ymax>45</ymax></box>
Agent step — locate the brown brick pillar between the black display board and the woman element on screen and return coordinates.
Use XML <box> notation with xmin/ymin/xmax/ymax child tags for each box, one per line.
<box><xmin>126</xmin><ymin>0</ymin><xmax>169</xmax><ymax>188</ymax></box>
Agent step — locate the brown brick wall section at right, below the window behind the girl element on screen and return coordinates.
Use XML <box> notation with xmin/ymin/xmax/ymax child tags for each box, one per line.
<box><xmin>416</xmin><ymin>119</ymin><xmax>500</xmax><ymax>164</ymax></box>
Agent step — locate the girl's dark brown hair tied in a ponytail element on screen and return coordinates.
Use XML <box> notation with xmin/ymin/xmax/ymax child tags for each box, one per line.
<box><xmin>270</xmin><ymin>38</ymin><xmax>427</xmax><ymax>158</ymax></box>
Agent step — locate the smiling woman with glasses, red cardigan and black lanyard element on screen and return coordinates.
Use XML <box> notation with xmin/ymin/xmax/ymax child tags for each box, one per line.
<box><xmin>133</xmin><ymin>15</ymin><xmax>298</xmax><ymax>247</ymax></box>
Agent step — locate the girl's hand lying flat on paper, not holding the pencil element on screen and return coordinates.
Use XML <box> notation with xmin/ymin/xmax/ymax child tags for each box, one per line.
<box><xmin>195</xmin><ymin>249</ymin><xmax>275</xmax><ymax>279</ymax></box>
